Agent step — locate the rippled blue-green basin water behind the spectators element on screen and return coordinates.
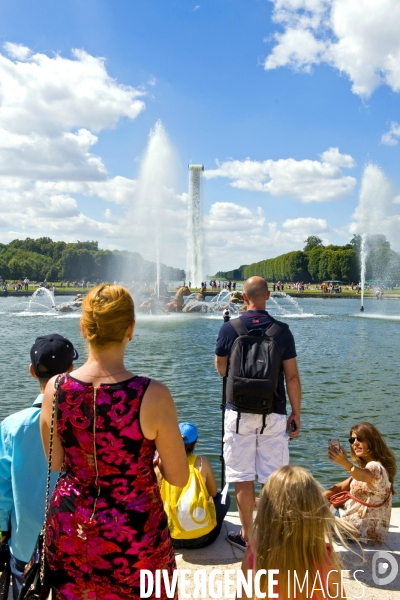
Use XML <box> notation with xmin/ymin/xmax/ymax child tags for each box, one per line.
<box><xmin>0</xmin><ymin>298</ymin><xmax>400</xmax><ymax>506</ymax></box>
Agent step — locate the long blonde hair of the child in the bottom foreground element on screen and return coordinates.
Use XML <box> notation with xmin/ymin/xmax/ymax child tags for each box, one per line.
<box><xmin>250</xmin><ymin>466</ymin><xmax>355</xmax><ymax>600</ymax></box>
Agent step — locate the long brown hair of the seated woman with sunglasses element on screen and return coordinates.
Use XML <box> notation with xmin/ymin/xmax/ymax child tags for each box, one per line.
<box><xmin>350</xmin><ymin>421</ymin><xmax>397</xmax><ymax>494</ymax></box>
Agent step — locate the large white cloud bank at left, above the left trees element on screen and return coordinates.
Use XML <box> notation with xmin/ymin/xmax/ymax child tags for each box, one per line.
<box><xmin>0</xmin><ymin>42</ymin><xmax>155</xmax><ymax>256</ymax></box>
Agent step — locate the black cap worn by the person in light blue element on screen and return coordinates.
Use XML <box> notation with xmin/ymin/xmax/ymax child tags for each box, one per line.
<box><xmin>31</xmin><ymin>333</ymin><xmax>78</xmax><ymax>379</ymax></box>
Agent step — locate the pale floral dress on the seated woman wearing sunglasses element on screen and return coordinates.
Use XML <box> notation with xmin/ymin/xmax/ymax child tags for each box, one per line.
<box><xmin>339</xmin><ymin>461</ymin><xmax>392</xmax><ymax>546</ymax></box>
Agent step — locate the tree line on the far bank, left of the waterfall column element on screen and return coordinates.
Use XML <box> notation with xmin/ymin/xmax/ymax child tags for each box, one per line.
<box><xmin>0</xmin><ymin>237</ymin><xmax>185</xmax><ymax>282</ymax></box>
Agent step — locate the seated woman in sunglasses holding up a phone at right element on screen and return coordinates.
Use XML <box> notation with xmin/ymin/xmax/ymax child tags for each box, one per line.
<box><xmin>324</xmin><ymin>422</ymin><xmax>396</xmax><ymax>546</ymax></box>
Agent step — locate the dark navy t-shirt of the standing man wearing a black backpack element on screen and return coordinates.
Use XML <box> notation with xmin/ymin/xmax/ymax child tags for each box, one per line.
<box><xmin>215</xmin><ymin>310</ymin><xmax>297</xmax><ymax>415</ymax></box>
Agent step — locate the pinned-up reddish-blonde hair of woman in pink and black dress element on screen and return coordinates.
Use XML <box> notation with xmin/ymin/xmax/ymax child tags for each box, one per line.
<box><xmin>81</xmin><ymin>283</ymin><xmax>135</xmax><ymax>346</ymax></box>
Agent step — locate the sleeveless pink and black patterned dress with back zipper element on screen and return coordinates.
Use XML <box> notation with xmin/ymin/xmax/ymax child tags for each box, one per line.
<box><xmin>46</xmin><ymin>374</ymin><xmax>175</xmax><ymax>600</ymax></box>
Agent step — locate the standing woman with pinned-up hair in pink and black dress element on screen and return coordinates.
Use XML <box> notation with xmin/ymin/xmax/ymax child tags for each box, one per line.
<box><xmin>41</xmin><ymin>284</ymin><xmax>189</xmax><ymax>600</ymax></box>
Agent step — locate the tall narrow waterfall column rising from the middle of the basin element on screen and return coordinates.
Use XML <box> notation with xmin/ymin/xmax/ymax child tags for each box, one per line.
<box><xmin>186</xmin><ymin>165</ymin><xmax>205</xmax><ymax>287</ymax></box>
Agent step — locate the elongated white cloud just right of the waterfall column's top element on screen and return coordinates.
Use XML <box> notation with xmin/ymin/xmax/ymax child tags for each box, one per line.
<box><xmin>204</xmin><ymin>148</ymin><xmax>356</xmax><ymax>202</ymax></box>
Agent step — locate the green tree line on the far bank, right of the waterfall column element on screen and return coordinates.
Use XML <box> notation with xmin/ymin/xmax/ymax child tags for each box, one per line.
<box><xmin>215</xmin><ymin>234</ymin><xmax>400</xmax><ymax>283</ymax></box>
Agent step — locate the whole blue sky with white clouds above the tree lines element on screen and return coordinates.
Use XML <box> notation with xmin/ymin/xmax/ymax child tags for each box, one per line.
<box><xmin>0</xmin><ymin>0</ymin><xmax>400</xmax><ymax>274</ymax></box>
